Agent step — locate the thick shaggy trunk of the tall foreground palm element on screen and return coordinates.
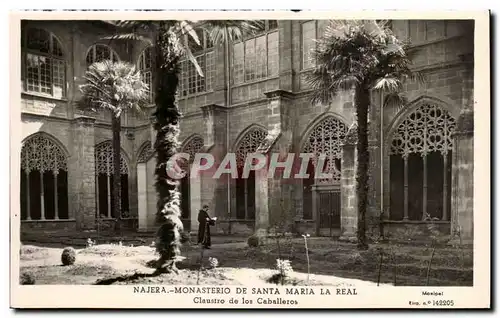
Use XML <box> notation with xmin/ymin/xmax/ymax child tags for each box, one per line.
<box><xmin>155</xmin><ymin>21</ymin><xmax>183</xmax><ymax>270</ymax></box>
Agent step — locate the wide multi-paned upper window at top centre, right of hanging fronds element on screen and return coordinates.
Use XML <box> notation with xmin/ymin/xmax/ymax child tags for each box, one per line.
<box><xmin>232</xmin><ymin>20</ymin><xmax>279</xmax><ymax>84</ymax></box>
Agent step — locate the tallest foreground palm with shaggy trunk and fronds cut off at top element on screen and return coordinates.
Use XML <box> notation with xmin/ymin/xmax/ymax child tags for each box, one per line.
<box><xmin>115</xmin><ymin>20</ymin><xmax>262</xmax><ymax>272</ymax></box>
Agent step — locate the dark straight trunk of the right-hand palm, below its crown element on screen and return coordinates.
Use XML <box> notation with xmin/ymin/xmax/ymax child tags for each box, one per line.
<box><xmin>354</xmin><ymin>85</ymin><xmax>370</xmax><ymax>250</ymax></box>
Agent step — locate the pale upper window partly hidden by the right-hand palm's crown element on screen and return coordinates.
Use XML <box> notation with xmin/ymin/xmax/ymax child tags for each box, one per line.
<box><xmin>300</xmin><ymin>20</ymin><xmax>328</xmax><ymax>70</ymax></box>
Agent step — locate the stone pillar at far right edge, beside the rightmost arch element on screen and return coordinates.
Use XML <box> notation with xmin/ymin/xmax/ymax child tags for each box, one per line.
<box><xmin>450</xmin><ymin>108</ymin><xmax>474</xmax><ymax>245</ymax></box>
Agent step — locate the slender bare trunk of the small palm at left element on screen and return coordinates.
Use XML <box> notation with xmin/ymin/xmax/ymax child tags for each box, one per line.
<box><xmin>111</xmin><ymin>114</ymin><xmax>121</xmax><ymax>230</ymax></box>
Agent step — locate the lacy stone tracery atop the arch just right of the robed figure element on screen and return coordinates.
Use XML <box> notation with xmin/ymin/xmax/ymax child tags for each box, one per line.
<box><xmin>232</xmin><ymin>124</ymin><xmax>268</xmax><ymax>167</ymax></box>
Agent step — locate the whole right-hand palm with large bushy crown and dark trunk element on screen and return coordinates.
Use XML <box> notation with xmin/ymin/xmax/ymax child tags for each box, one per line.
<box><xmin>308</xmin><ymin>20</ymin><xmax>421</xmax><ymax>249</ymax></box>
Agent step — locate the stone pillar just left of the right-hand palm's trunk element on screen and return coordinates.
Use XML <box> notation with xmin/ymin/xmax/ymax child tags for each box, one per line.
<box><xmin>339</xmin><ymin>123</ymin><xmax>358</xmax><ymax>242</ymax></box>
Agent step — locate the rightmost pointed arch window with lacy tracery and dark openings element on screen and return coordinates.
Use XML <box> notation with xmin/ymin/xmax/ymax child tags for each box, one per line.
<box><xmin>389</xmin><ymin>104</ymin><xmax>455</xmax><ymax>221</ymax></box>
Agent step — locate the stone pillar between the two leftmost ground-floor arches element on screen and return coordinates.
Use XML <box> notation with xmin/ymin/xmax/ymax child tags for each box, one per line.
<box><xmin>69</xmin><ymin>116</ymin><xmax>97</xmax><ymax>230</ymax></box>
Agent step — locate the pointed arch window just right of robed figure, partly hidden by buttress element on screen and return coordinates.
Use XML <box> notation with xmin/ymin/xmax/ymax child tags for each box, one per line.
<box><xmin>236</xmin><ymin>128</ymin><xmax>267</xmax><ymax>220</ymax></box>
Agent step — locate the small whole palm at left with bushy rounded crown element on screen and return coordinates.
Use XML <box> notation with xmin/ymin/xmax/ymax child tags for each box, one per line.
<box><xmin>79</xmin><ymin>60</ymin><xmax>148</xmax><ymax>228</ymax></box>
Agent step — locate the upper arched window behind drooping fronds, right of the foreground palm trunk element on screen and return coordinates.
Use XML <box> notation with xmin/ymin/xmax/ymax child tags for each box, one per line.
<box><xmin>179</xmin><ymin>30</ymin><xmax>215</xmax><ymax>97</ymax></box>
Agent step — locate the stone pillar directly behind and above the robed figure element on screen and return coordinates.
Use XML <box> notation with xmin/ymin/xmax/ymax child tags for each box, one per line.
<box><xmin>200</xmin><ymin>104</ymin><xmax>232</xmax><ymax>232</ymax></box>
